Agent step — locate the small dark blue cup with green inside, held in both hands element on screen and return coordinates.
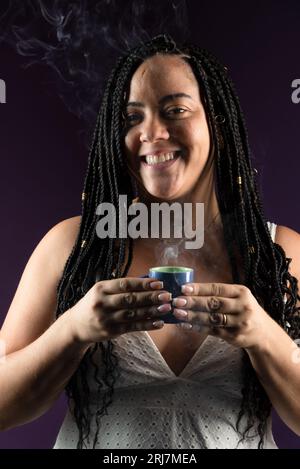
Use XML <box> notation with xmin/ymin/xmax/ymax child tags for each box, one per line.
<box><xmin>148</xmin><ymin>266</ymin><xmax>194</xmax><ymax>324</ymax></box>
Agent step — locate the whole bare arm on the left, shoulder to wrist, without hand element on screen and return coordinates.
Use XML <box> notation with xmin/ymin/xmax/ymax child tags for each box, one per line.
<box><xmin>0</xmin><ymin>217</ymin><xmax>88</xmax><ymax>430</ymax></box>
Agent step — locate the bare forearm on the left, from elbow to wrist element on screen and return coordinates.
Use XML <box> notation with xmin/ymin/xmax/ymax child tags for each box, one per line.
<box><xmin>0</xmin><ymin>310</ymin><xmax>89</xmax><ymax>430</ymax></box>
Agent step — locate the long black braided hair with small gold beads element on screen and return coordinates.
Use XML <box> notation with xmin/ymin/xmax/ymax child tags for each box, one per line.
<box><xmin>57</xmin><ymin>35</ymin><xmax>300</xmax><ymax>448</ymax></box>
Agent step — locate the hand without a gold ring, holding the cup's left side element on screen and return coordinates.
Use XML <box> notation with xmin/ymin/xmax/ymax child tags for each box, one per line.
<box><xmin>70</xmin><ymin>277</ymin><xmax>172</xmax><ymax>344</ymax></box>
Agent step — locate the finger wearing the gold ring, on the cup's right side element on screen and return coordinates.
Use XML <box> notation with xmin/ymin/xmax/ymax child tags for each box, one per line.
<box><xmin>173</xmin><ymin>308</ymin><xmax>238</xmax><ymax>328</ymax></box>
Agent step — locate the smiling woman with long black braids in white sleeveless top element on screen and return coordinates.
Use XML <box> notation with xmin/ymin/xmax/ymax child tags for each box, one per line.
<box><xmin>0</xmin><ymin>35</ymin><xmax>300</xmax><ymax>448</ymax></box>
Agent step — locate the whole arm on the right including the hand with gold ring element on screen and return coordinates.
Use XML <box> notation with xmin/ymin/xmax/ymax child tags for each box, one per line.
<box><xmin>172</xmin><ymin>227</ymin><xmax>300</xmax><ymax>435</ymax></box>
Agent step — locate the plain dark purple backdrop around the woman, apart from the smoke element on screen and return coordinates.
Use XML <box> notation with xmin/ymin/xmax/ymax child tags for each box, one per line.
<box><xmin>0</xmin><ymin>0</ymin><xmax>300</xmax><ymax>448</ymax></box>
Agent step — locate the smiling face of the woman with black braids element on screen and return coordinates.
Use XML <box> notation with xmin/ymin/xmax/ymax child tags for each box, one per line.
<box><xmin>125</xmin><ymin>54</ymin><xmax>210</xmax><ymax>200</ymax></box>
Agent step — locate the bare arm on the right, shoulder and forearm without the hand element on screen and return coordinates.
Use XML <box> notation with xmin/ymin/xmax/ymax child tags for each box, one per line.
<box><xmin>246</xmin><ymin>226</ymin><xmax>300</xmax><ymax>436</ymax></box>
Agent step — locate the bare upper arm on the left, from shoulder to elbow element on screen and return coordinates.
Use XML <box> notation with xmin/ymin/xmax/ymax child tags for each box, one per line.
<box><xmin>1</xmin><ymin>216</ymin><xmax>81</xmax><ymax>354</ymax></box>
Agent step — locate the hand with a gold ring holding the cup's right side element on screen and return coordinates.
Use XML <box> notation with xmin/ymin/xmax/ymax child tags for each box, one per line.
<box><xmin>172</xmin><ymin>283</ymin><xmax>273</xmax><ymax>348</ymax></box>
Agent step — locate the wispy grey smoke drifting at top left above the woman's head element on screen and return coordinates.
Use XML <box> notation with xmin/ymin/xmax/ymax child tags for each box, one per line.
<box><xmin>0</xmin><ymin>0</ymin><xmax>189</xmax><ymax>145</ymax></box>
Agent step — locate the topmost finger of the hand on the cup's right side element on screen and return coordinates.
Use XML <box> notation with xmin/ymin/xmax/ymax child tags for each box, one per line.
<box><xmin>181</xmin><ymin>283</ymin><xmax>246</xmax><ymax>298</ymax></box>
